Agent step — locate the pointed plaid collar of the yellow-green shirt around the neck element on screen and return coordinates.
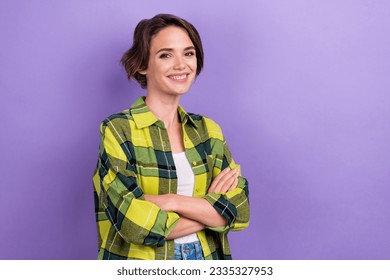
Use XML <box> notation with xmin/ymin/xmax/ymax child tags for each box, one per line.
<box><xmin>130</xmin><ymin>96</ymin><xmax>198</xmax><ymax>128</ymax></box>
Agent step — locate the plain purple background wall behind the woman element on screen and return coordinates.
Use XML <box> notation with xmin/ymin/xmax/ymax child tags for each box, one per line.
<box><xmin>0</xmin><ymin>0</ymin><xmax>390</xmax><ymax>259</ymax></box>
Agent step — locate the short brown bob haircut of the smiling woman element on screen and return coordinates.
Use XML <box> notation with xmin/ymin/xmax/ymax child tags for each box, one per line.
<box><xmin>121</xmin><ymin>14</ymin><xmax>203</xmax><ymax>88</ymax></box>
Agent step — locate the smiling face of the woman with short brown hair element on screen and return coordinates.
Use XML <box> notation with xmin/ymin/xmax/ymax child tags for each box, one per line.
<box><xmin>140</xmin><ymin>26</ymin><xmax>197</xmax><ymax>96</ymax></box>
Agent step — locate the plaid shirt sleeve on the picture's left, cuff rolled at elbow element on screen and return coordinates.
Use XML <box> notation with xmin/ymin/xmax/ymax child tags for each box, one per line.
<box><xmin>94</xmin><ymin>123</ymin><xmax>179</xmax><ymax>246</ymax></box>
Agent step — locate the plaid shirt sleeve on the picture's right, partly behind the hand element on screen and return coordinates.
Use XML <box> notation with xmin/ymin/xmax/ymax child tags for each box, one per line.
<box><xmin>204</xmin><ymin>126</ymin><xmax>250</xmax><ymax>232</ymax></box>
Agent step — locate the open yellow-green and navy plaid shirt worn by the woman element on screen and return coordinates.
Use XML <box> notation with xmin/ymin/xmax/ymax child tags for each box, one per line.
<box><xmin>93</xmin><ymin>97</ymin><xmax>249</xmax><ymax>259</ymax></box>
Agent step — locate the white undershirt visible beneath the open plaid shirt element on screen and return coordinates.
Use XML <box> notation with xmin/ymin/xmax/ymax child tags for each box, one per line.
<box><xmin>172</xmin><ymin>152</ymin><xmax>198</xmax><ymax>244</ymax></box>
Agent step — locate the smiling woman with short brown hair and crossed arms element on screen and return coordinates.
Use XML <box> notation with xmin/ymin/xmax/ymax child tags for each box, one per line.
<box><xmin>93</xmin><ymin>14</ymin><xmax>249</xmax><ymax>259</ymax></box>
